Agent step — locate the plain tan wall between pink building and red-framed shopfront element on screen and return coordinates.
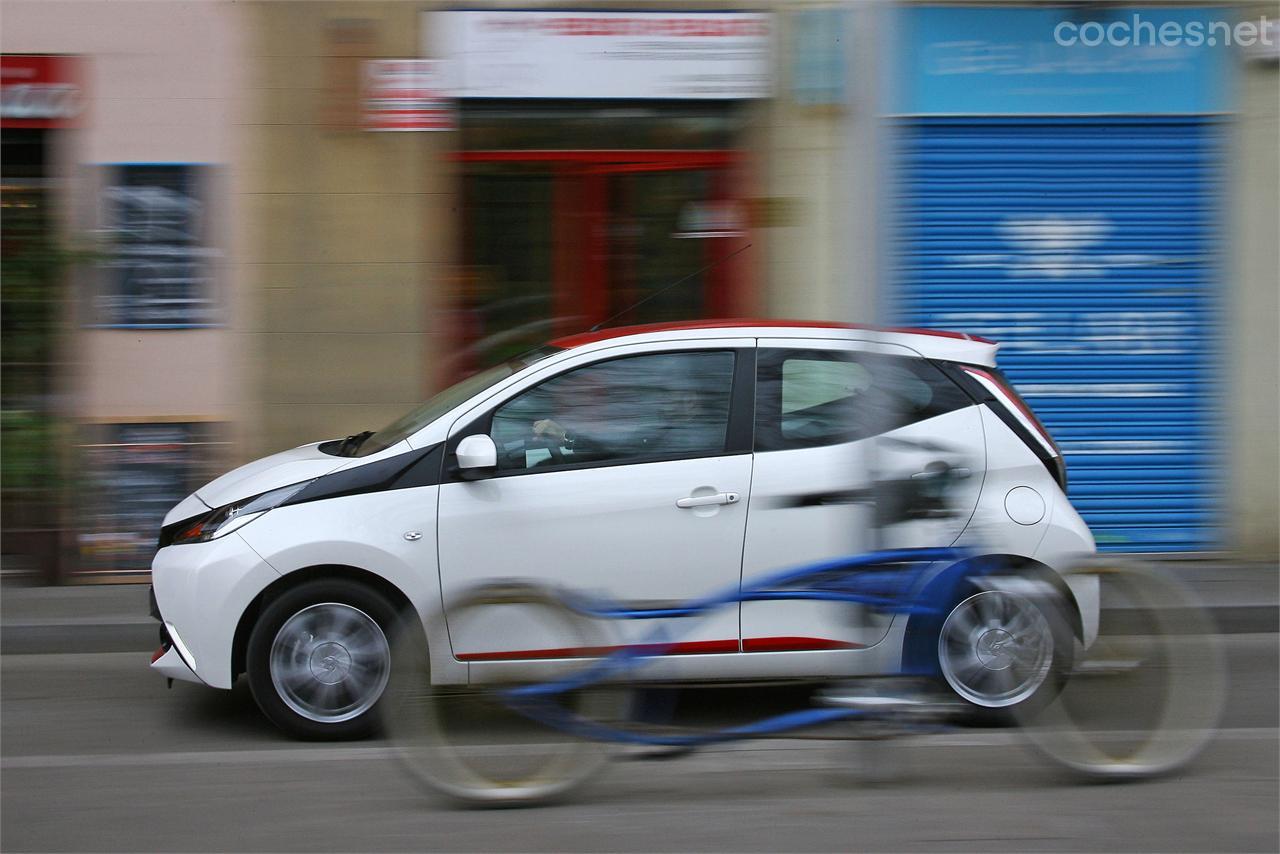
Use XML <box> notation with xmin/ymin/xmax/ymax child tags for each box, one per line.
<box><xmin>242</xmin><ymin>3</ymin><xmax>453</xmax><ymax>453</ymax></box>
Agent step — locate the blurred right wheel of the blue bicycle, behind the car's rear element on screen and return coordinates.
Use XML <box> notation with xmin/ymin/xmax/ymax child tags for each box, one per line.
<box><xmin>1020</xmin><ymin>563</ymin><xmax>1226</xmax><ymax>780</ymax></box>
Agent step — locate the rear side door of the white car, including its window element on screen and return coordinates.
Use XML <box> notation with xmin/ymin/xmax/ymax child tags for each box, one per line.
<box><xmin>742</xmin><ymin>339</ymin><xmax>986</xmax><ymax>653</ymax></box>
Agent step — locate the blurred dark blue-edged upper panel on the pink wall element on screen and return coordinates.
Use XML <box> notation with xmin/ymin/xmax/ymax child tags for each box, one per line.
<box><xmin>90</xmin><ymin>164</ymin><xmax>223</xmax><ymax>329</ymax></box>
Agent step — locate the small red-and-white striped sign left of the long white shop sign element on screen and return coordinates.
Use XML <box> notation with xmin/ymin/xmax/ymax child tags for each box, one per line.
<box><xmin>364</xmin><ymin>59</ymin><xmax>456</xmax><ymax>131</ymax></box>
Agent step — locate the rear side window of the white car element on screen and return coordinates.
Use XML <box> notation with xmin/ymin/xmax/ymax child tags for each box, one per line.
<box><xmin>755</xmin><ymin>348</ymin><xmax>972</xmax><ymax>451</ymax></box>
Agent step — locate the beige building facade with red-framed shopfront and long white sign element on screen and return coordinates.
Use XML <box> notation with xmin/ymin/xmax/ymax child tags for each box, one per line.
<box><xmin>246</xmin><ymin>3</ymin><xmax>845</xmax><ymax>460</ymax></box>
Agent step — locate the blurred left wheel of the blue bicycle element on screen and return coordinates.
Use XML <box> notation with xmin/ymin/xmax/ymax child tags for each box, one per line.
<box><xmin>385</xmin><ymin>585</ymin><xmax>612</xmax><ymax>805</ymax></box>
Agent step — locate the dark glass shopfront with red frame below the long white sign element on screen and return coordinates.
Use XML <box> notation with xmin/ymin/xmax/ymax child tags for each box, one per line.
<box><xmin>445</xmin><ymin>101</ymin><xmax>750</xmax><ymax>376</ymax></box>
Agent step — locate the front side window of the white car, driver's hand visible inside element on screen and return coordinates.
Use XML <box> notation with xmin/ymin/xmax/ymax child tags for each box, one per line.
<box><xmin>489</xmin><ymin>351</ymin><xmax>735</xmax><ymax>474</ymax></box>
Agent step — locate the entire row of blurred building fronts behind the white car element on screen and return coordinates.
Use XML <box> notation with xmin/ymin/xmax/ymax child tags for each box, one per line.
<box><xmin>0</xmin><ymin>0</ymin><xmax>1280</xmax><ymax>579</ymax></box>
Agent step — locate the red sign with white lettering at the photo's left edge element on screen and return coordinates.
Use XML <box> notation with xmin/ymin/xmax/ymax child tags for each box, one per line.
<box><xmin>0</xmin><ymin>54</ymin><xmax>84</xmax><ymax>128</ymax></box>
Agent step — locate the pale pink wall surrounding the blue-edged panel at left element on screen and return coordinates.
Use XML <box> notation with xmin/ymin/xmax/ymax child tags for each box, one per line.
<box><xmin>0</xmin><ymin>0</ymin><xmax>244</xmax><ymax>440</ymax></box>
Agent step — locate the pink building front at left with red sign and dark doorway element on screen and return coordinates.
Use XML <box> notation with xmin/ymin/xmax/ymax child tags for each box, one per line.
<box><xmin>0</xmin><ymin>1</ymin><xmax>250</xmax><ymax>579</ymax></box>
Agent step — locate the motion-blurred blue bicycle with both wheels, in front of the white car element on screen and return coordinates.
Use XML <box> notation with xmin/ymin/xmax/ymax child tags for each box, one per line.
<box><xmin>389</xmin><ymin>548</ymin><xmax>1225</xmax><ymax>804</ymax></box>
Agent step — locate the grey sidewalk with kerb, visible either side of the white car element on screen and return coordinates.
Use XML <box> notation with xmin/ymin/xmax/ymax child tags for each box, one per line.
<box><xmin>0</xmin><ymin>561</ymin><xmax>1280</xmax><ymax>654</ymax></box>
